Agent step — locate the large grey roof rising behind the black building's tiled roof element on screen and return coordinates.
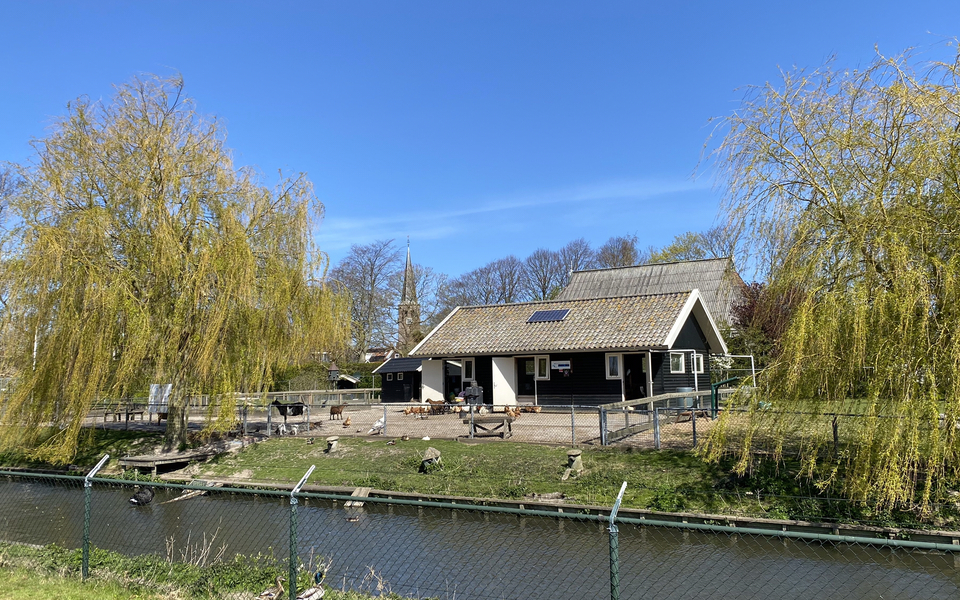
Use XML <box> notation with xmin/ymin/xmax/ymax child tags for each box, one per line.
<box><xmin>557</xmin><ymin>258</ymin><xmax>743</xmax><ymax>323</ymax></box>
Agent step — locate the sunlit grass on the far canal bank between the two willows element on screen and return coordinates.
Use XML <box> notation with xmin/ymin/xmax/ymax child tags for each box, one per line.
<box><xmin>202</xmin><ymin>438</ymin><xmax>721</xmax><ymax>506</ymax></box>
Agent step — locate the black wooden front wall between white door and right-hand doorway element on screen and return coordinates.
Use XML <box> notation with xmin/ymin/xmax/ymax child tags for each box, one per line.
<box><xmin>537</xmin><ymin>352</ymin><xmax>623</xmax><ymax>406</ymax></box>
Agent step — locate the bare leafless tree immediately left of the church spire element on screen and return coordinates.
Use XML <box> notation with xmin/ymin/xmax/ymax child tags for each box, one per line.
<box><xmin>330</xmin><ymin>240</ymin><xmax>402</xmax><ymax>360</ymax></box>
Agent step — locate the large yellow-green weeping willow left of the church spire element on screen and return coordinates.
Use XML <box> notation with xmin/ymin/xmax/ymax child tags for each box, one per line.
<box><xmin>0</xmin><ymin>78</ymin><xmax>349</xmax><ymax>461</ymax></box>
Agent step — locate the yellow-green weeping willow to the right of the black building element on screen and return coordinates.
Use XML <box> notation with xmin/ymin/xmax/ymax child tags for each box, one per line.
<box><xmin>703</xmin><ymin>47</ymin><xmax>960</xmax><ymax>511</ymax></box>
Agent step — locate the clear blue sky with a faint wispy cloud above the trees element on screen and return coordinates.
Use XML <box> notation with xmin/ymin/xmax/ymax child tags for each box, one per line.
<box><xmin>0</xmin><ymin>0</ymin><xmax>960</xmax><ymax>276</ymax></box>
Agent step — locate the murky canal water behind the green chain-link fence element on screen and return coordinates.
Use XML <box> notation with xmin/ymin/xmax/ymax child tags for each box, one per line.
<box><xmin>0</xmin><ymin>472</ymin><xmax>960</xmax><ymax>600</ymax></box>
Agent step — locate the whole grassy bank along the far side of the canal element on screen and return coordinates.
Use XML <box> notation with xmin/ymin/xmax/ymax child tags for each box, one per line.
<box><xmin>0</xmin><ymin>429</ymin><xmax>944</xmax><ymax>528</ymax></box>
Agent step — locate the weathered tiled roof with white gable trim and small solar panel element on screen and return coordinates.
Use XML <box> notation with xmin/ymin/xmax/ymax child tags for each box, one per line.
<box><xmin>410</xmin><ymin>290</ymin><xmax>726</xmax><ymax>357</ymax></box>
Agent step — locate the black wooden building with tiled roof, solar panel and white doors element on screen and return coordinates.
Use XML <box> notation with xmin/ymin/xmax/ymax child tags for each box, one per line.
<box><xmin>410</xmin><ymin>289</ymin><xmax>726</xmax><ymax>406</ymax></box>
